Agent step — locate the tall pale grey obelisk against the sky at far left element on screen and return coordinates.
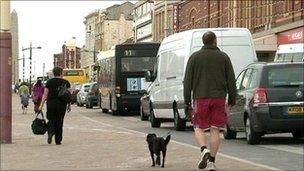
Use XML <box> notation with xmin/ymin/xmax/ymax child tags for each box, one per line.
<box><xmin>11</xmin><ymin>10</ymin><xmax>19</xmax><ymax>84</ymax></box>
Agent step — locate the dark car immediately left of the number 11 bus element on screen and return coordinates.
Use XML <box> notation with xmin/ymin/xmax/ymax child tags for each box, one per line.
<box><xmin>86</xmin><ymin>82</ymin><xmax>99</xmax><ymax>108</ymax></box>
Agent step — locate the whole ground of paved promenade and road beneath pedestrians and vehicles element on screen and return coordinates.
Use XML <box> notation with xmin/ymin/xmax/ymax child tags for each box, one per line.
<box><xmin>1</xmin><ymin>95</ymin><xmax>304</xmax><ymax>170</ymax></box>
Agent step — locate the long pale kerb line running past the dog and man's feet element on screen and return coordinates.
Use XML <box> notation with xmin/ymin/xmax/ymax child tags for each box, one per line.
<box><xmin>78</xmin><ymin>114</ymin><xmax>280</xmax><ymax>170</ymax></box>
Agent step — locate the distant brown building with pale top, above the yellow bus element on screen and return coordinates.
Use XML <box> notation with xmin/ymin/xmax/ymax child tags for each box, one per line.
<box><xmin>54</xmin><ymin>38</ymin><xmax>81</xmax><ymax>69</ymax></box>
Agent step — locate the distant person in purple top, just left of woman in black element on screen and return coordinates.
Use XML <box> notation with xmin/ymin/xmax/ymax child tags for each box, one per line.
<box><xmin>32</xmin><ymin>80</ymin><xmax>44</xmax><ymax>113</ymax></box>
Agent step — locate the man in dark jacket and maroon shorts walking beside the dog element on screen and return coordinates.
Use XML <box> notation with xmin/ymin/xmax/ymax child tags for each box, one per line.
<box><xmin>184</xmin><ymin>31</ymin><xmax>236</xmax><ymax>170</ymax></box>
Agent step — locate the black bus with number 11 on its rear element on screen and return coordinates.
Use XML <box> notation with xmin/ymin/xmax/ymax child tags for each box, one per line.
<box><xmin>98</xmin><ymin>43</ymin><xmax>160</xmax><ymax>115</ymax></box>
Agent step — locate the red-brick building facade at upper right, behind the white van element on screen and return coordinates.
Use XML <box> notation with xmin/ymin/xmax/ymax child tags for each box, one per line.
<box><xmin>178</xmin><ymin>0</ymin><xmax>304</xmax><ymax>61</ymax></box>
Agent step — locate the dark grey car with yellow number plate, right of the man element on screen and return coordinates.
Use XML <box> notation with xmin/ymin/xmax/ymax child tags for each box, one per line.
<box><xmin>224</xmin><ymin>62</ymin><xmax>304</xmax><ymax>144</ymax></box>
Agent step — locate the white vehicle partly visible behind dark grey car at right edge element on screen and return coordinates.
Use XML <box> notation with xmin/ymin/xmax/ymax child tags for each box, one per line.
<box><xmin>274</xmin><ymin>43</ymin><xmax>304</xmax><ymax>62</ymax></box>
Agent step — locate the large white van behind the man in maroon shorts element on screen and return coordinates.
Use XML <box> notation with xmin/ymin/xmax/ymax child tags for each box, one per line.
<box><xmin>149</xmin><ymin>28</ymin><xmax>257</xmax><ymax>130</ymax></box>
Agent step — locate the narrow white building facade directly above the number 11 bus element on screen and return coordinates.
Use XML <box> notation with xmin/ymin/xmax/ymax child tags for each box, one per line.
<box><xmin>133</xmin><ymin>0</ymin><xmax>154</xmax><ymax>42</ymax></box>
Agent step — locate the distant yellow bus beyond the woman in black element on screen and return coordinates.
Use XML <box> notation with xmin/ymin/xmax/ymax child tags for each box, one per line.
<box><xmin>63</xmin><ymin>69</ymin><xmax>88</xmax><ymax>84</ymax></box>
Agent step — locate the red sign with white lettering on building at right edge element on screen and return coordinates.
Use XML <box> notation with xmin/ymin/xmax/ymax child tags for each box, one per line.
<box><xmin>278</xmin><ymin>27</ymin><xmax>304</xmax><ymax>45</ymax></box>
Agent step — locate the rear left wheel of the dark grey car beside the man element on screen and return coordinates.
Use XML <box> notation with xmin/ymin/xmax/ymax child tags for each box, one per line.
<box><xmin>245</xmin><ymin>117</ymin><xmax>261</xmax><ymax>145</ymax></box>
